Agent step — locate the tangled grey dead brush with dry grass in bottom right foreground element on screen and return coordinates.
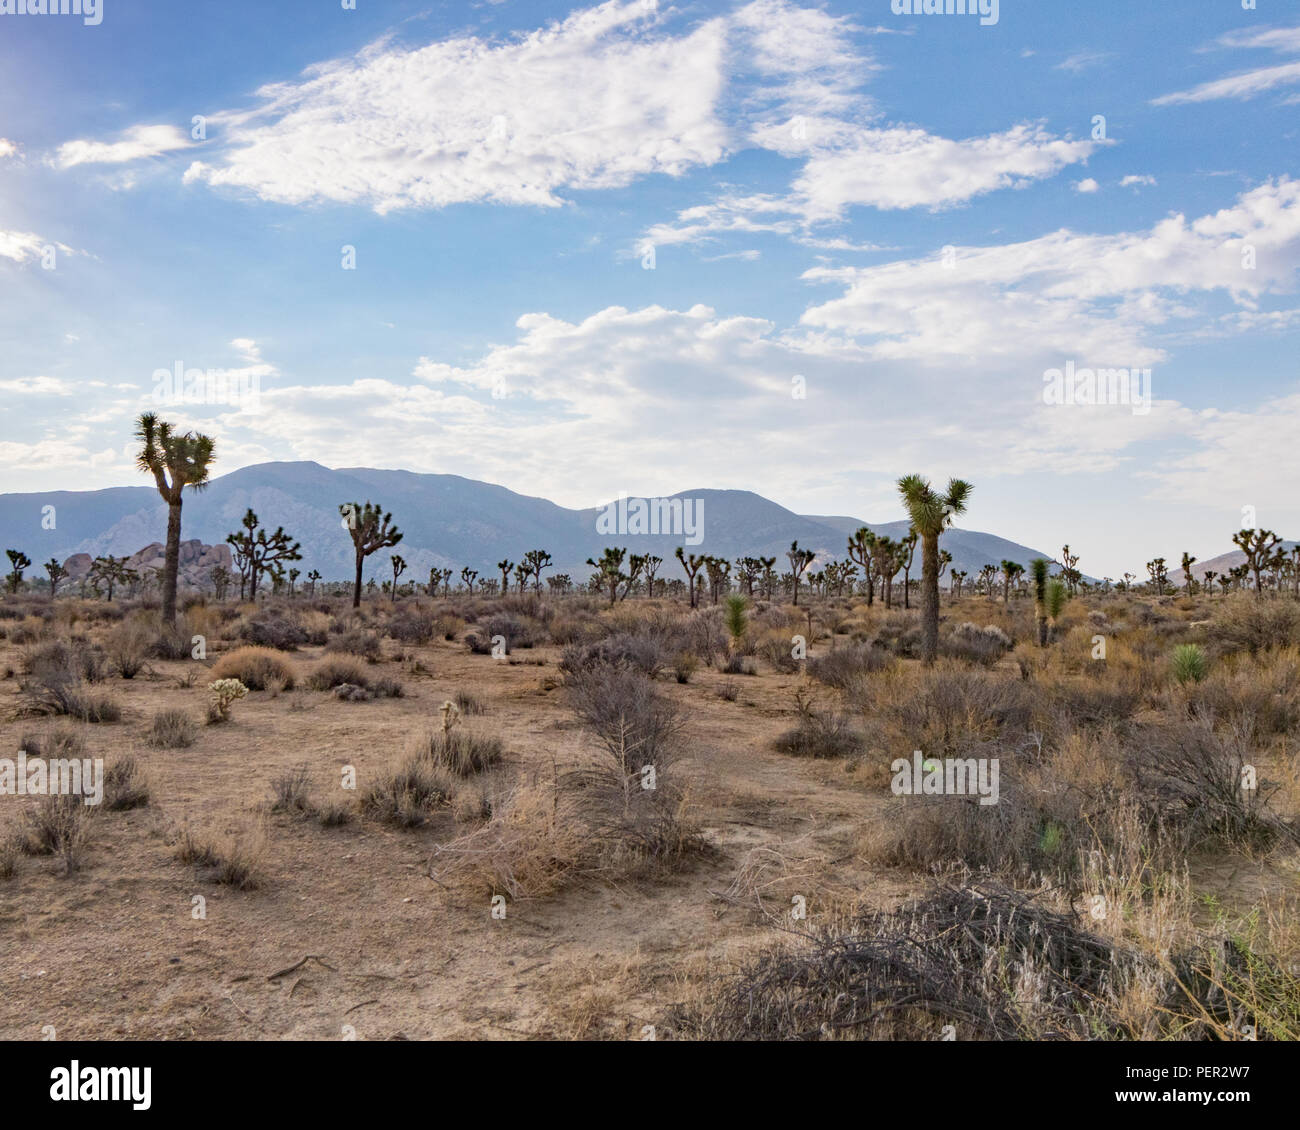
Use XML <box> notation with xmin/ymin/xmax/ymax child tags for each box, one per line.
<box><xmin>671</xmin><ymin>879</ymin><xmax>1300</xmax><ymax>1040</ymax></box>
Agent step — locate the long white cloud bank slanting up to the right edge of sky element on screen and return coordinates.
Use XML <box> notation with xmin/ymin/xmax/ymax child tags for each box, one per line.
<box><xmin>802</xmin><ymin>179</ymin><xmax>1300</xmax><ymax>365</ymax></box>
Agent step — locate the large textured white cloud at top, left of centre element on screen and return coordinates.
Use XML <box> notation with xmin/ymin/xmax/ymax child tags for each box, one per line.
<box><xmin>186</xmin><ymin>0</ymin><xmax>728</xmax><ymax>212</ymax></box>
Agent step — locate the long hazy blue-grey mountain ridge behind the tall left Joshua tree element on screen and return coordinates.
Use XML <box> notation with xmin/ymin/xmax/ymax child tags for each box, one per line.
<box><xmin>0</xmin><ymin>462</ymin><xmax>1066</xmax><ymax>581</ymax></box>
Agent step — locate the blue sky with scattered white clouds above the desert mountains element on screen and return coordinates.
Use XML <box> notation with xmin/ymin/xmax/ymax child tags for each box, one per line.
<box><xmin>0</xmin><ymin>0</ymin><xmax>1300</xmax><ymax>577</ymax></box>
